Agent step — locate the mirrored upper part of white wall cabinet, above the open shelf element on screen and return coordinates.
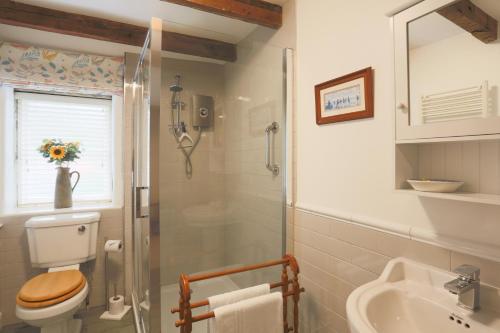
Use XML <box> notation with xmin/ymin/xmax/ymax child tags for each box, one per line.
<box><xmin>394</xmin><ymin>0</ymin><xmax>500</xmax><ymax>140</ymax></box>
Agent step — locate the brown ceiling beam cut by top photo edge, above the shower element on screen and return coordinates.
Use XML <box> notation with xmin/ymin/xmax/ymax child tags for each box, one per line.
<box><xmin>162</xmin><ymin>0</ymin><xmax>283</xmax><ymax>29</ymax></box>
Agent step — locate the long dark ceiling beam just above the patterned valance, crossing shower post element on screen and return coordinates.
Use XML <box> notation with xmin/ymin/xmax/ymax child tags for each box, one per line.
<box><xmin>0</xmin><ymin>0</ymin><xmax>236</xmax><ymax>61</ymax></box>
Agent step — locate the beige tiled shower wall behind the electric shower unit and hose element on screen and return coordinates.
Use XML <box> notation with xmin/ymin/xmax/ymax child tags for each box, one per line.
<box><xmin>160</xmin><ymin>59</ymin><xmax>225</xmax><ymax>284</ymax></box>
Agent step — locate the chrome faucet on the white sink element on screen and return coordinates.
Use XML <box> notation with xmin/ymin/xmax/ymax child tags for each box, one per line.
<box><xmin>444</xmin><ymin>265</ymin><xmax>481</xmax><ymax>311</ymax></box>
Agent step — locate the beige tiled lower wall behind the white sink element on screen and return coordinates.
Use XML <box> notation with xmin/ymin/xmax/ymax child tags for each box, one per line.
<box><xmin>294</xmin><ymin>210</ymin><xmax>500</xmax><ymax>333</ymax></box>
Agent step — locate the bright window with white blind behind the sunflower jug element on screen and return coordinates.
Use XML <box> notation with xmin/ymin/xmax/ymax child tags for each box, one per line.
<box><xmin>15</xmin><ymin>92</ymin><xmax>114</xmax><ymax>207</ymax></box>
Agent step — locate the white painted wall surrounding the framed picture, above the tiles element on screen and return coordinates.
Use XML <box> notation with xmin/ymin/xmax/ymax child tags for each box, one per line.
<box><xmin>296</xmin><ymin>0</ymin><xmax>500</xmax><ymax>248</ymax></box>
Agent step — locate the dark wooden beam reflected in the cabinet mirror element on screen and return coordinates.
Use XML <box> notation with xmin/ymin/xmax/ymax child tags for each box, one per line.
<box><xmin>438</xmin><ymin>0</ymin><xmax>498</xmax><ymax>43</ymax></box>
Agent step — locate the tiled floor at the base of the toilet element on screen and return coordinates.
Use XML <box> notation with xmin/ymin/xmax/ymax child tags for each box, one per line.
<box><xmin>1</xmin><ymin>307</ymin><xmax>135</xmax><ymax>333</ymax></box>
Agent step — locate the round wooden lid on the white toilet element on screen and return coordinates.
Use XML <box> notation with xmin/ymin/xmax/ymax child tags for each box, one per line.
<box><xmin>17</xmin><ymin>270</ymin><xmax>86</xmax><ymax>305</ymax></box>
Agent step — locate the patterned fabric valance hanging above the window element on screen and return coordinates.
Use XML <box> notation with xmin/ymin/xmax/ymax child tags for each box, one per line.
<box><xmin>0</xmin><ymin>41</ymin><xmax>124</xmax><ymax>95</ymax></box>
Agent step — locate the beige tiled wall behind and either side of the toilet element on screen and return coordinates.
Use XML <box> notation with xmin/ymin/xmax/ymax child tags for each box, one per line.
<box><xmin>0</xmin><ymin>209</ymin><xmax>123</xmax><ymax>325</ymax></box>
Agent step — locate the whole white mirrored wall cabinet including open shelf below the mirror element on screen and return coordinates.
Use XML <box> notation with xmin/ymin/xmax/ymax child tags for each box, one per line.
<box><xmin>393</xmin><ymin>0</ymin><xmax>500</xmax><ymax>205</ymax></box>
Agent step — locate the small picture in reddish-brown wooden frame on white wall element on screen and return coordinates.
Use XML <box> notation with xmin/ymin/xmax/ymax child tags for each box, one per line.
<box><xmin>314</xmin><ymin>67</ymin><xmax>373</xmax><ymax>125</ymax></box>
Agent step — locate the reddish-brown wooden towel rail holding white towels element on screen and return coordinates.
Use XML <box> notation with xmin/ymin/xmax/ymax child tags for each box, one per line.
<box><xmin>171</xmin><ymin>254</ymin><xmax>305</xmax><ymax>333</ymax></box>
